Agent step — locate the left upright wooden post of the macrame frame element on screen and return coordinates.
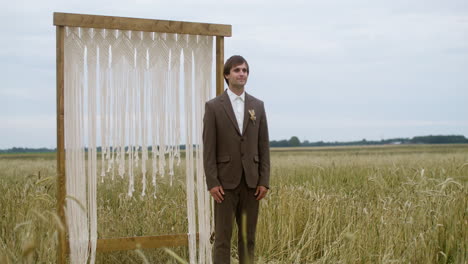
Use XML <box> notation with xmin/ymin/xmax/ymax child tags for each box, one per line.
<box><xmin>56</xmin><ymin>26</ymin><xmax>68</xmax><ymax>264</ymax></box>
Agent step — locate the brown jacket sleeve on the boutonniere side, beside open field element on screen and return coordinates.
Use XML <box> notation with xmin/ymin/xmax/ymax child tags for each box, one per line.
<box><xmin>258</xmin><ymin>104</ymin><xmax>270</xmax><ymax>188</ymax></box>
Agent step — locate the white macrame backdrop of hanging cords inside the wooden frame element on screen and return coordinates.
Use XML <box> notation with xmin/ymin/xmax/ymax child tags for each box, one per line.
<box><xmin>64</xmin><ymin>27</ymin><xmax>213</xmax><ymax>264</ymax></box>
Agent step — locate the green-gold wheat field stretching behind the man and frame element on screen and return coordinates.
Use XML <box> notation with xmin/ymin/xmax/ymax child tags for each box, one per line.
<box><xmin>0</xmin><ymin>145</ymin><xmax>468</xmax><ymax>263</ymax></box>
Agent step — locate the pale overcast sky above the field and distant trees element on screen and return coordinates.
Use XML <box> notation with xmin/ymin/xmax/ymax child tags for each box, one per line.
<box><xmin>0</xmin><ymin>0</ymin><xmax>468</xmax><ymax>148</ymax></box>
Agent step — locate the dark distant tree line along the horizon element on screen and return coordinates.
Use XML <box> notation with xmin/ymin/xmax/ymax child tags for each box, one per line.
<box><xmin>0</xmin><ymin>135</ymin><xmax>468</xmax><ymax>154</ymax></box>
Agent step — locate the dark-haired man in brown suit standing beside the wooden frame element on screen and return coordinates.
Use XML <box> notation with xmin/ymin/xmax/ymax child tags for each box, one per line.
<box><xmin>203</xmin><ymin>55</ymin><xmax>270</xmax><ymax>264</ymax></box>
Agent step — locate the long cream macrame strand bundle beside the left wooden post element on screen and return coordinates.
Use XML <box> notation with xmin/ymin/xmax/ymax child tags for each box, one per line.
<box><xmin>64</xmin><ymin>25</ymin><xmax>89</xmax><ymax>263</ymax></box>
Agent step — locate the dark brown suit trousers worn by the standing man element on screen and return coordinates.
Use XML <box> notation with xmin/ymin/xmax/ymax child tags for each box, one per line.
<box><xmin>213</xmin><ymin>174</ymin><xmax>259</xmax><ymax>264</ymax></box>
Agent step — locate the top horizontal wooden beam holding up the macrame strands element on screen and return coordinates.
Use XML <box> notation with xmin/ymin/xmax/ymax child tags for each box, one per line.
<box><xmin>54</xmin><ymin>12</ymin><xmax>232</xmax><ymax>37</ymax></box>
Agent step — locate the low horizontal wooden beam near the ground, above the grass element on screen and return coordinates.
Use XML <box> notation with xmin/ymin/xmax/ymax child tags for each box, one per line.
<box><xmin>96</xmin><ymin>234</ymin><xmax>192</xmax><ymax>252</ymax></box>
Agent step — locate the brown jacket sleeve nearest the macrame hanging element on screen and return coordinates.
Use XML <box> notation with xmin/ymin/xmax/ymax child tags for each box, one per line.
<box><xmin>203</xmin><ymin>103</ymin><xmax>221</xmax><ymax>190</ymax></box>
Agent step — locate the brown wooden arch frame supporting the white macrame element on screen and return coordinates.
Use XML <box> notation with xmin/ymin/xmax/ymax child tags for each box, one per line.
<box><xmin>54</xmin><ymin>13</ymin><xmax>232</xmax><ymax>263</ymax></box>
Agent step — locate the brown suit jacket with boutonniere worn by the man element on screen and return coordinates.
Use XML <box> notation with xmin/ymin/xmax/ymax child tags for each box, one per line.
<box><xmin>203</xmin><ymin>91</ymin><xmax>270</xmax><ymax>189</ymax></box>
